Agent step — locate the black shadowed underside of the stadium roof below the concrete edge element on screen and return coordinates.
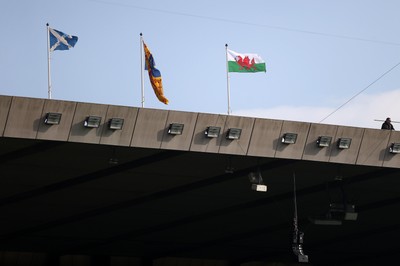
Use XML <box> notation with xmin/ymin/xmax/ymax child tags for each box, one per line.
<box><xmin>0</xmin><ymin>138</ymin><xmax>400</xmax><ymax>265</ymax></box>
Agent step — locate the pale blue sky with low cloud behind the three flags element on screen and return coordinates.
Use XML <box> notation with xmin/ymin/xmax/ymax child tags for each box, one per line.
<box><xmin>0</xmin><ymin>0</ymin><xmax>400</xmax><ymax>128</ymax></box>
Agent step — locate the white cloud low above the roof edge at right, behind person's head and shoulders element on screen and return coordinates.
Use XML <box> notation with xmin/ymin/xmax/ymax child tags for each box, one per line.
<box><xmin>234</xmin><ymin>89</ymin><xmax>400</xmax><ymax>129</ymax></box>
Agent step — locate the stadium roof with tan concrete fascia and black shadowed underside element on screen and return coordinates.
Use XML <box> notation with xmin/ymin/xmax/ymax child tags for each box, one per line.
<box><xmin>0</xmin><ymin>96</ymin><xmax>400</xmax><ymax>265</ymax></box>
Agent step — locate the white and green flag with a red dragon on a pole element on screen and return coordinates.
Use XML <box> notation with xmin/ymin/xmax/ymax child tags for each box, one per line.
<box><xmin>227</xmin><ymin>49</ymin><xmax>266</xmax><ymax>72</ymax></box>
